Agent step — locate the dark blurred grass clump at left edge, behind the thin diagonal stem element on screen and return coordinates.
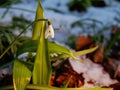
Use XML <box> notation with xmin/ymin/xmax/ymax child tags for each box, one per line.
<box><xmin>0</xmin><ymin>30</ymin><xmax>21</xmax><ymax>66</ymax></box>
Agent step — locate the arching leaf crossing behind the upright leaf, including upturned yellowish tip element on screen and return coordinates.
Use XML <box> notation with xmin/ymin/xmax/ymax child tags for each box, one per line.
<box><xmin>17</xmin><ymin>40</ymin><xmax>98</xmax><ymax>59</ymax></box>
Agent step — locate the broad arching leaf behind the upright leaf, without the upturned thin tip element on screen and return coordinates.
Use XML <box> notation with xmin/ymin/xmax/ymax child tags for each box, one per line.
<box><xmin>16</xmin><ymin>40</ymin><xmax>75</xmax><ymax>58</ymax></box>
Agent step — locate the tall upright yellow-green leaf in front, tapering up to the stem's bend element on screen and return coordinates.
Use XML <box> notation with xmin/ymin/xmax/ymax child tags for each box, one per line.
<box><xmin>33</xmin><ymin>19</ymin><xmax>51</xmax><ymax>85</ymax></box>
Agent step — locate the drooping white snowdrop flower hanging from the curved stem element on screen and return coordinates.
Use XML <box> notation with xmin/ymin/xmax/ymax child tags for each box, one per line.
<box><xmin>45</xmin><ymin>21</ymin><xmax>55</xmax><ymax>39</ymax></box>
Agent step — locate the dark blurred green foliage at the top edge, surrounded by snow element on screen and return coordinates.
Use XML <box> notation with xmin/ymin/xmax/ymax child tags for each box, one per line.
<box><xmin>67</xmin><ymin>0</ymin><xmax>106</xmax><ymax>12</ymax></box>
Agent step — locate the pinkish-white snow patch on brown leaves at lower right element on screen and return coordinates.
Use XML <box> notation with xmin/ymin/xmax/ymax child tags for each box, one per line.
<box><xmin>69</xmin><ymin>56</ymin><xmax>118</xmax><ymax>88</ymax></box>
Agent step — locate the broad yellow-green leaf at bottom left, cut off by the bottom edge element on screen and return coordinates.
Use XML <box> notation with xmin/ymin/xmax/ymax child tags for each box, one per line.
<box><xmin>13</xmin><ymin>59</ymin><xmax>32</xmax><ymax>90</ymax></box>
